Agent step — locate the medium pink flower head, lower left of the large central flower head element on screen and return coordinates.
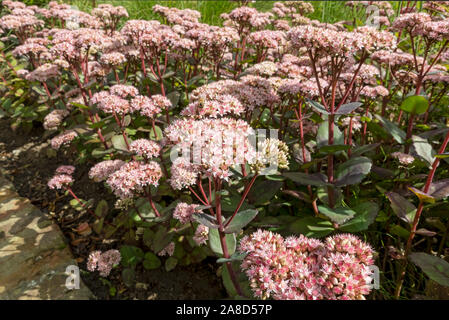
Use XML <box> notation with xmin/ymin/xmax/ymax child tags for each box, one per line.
<box><xmin>106</xmin><ymin>160</ymin><xmax>162</xmax><ymax>199</ymax></box>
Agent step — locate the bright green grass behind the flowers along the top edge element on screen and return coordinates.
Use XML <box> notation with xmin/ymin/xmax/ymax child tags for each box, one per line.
<box><xmin>65</xmin><ymin>0</ymin><xmax>368</xmax><ymax>25</ymax></box>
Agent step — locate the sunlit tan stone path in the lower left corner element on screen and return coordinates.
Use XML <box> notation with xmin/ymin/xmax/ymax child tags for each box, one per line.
<box><xmin>0</xmin><ymin>168</ymin><xmax>94</xmax><ymax>300</ymax></box>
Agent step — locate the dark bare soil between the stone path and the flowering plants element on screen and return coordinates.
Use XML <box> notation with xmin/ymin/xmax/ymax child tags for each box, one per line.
<box><xmin>0</xmin><ymin>119</ymin><xmax>227</xmax><ymax>300</ymax></box>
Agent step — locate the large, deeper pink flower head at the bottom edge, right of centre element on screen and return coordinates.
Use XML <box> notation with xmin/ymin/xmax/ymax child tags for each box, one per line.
<box><xmin>239</xmin><ymin>230</ymin><xmax>374</xmax><ymax>300</ymax></box>
